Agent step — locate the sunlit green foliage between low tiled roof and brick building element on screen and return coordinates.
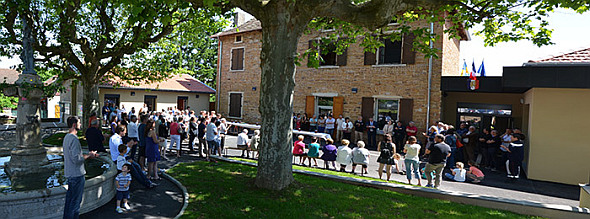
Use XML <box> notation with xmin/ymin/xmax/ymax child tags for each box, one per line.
<box><xmin>126</xmin><ymin>7</ymin><xmax>231</xmax><ymax>87</ymax></box>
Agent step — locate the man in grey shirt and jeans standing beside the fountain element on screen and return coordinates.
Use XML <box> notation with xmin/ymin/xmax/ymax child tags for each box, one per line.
<box><xmin>62</xmin><ymin>116</ymin><xmax>99</xmax><ymax>219</ymax></box>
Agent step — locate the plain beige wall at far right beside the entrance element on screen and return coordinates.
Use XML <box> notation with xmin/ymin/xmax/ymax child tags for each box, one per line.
<box><xmin>524</xmin><ymin>88</ymin><xmax>590</xmax><ymax>185</ymax></box>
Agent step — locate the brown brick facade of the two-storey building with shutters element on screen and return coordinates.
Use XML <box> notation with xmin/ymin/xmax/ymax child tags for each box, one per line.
<box><xmin>216</xmin><ymin>19</ymin><xmax>460</xmax><ymax>133</ymax></box>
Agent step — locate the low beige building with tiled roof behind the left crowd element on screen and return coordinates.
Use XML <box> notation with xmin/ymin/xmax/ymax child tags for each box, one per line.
<box><xmin>60</xmin><ymin>74</ymin><xmax>215</xmax><ymax>118</ymax></box>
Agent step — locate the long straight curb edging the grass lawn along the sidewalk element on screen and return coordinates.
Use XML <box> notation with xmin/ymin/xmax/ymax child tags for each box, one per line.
<box><xmin>211</xmin><ymin>156</ymin><xmax>590</xmax><ymax>219</ymax></box>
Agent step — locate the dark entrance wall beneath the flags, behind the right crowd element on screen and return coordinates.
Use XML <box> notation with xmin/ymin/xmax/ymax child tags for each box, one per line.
<box><xmin>442</xmin><ymin>91</ymin><xmax>524</xmax><ymax>127</ymax></box>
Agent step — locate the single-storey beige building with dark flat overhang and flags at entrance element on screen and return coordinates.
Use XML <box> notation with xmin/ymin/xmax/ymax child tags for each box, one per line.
<box><xmin>442</xmin><ymin>49</ymin><xmax>590</xmax><ymax>185</ymax></box>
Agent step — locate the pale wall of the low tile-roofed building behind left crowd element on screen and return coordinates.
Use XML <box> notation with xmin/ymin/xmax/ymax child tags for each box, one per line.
<box><xmin>99</xmin><ymin>88</ymin><xmax>209</xmax><ymax>112</ymax></box>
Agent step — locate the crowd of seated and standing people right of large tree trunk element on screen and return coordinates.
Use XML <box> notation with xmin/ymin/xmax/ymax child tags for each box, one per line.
<box><xmin>293</xmin><ymin>114</ymin><xmax>525</xmax><ymax>188</ymax></box>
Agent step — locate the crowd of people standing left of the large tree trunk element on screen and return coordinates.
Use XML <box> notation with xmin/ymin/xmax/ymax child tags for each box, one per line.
<box><xmin>75</xmin><ymin>104</ymin><xmax>239</xmax><ymax>215</ymax></box>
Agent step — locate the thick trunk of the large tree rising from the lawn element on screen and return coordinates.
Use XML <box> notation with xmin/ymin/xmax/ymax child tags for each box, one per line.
<box><xmin>256</xmin><ymin>11</ymin><xmax>305</xmax><ymax>190</ymax></box>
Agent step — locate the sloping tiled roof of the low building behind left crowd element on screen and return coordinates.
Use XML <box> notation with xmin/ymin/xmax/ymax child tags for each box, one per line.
<box><xmin>99</xmin><ymin>74</ymin><xmax>215</xmax><ymax>94</ymax></box>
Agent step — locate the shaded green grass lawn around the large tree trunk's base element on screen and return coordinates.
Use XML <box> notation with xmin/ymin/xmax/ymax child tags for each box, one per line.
<box><xmin>168</xmin><ymin>162</ymin><xmax>531</xmax><ymax>218</ymax></box>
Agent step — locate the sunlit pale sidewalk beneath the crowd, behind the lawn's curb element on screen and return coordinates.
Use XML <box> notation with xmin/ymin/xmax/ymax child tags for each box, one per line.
<box><xmin>226</xmin><ymin>136</ymin><xmax>580</xmax><ymax>206</ymax></box>
